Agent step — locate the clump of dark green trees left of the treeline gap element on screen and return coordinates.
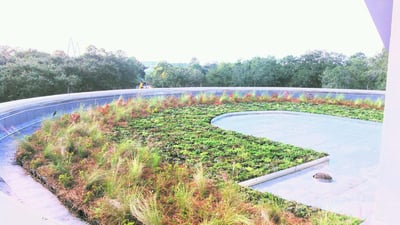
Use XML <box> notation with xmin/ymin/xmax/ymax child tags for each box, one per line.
<box><xmin>0</xmin><ymin>46</ymin><xmax>145</xmax><ymax>102</ymax></box>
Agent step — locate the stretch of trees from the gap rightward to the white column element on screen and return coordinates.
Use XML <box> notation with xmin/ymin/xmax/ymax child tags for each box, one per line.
<box><xmin>146</xmin><ymin>51</ymin><xmax>387</xmax><ymax>90</ymax></box>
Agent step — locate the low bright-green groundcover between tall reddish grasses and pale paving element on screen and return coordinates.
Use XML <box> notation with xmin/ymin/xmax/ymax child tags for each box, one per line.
<box><xmin>120</xmin><ymin>102</ymin><xmax>377</xmax><ymax>181</ymax></box>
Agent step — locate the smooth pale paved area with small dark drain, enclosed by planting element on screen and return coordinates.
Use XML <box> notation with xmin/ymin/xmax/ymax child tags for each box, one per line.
<box><xmin>213</xmin><ymin>111</ymin><xmax>382</xmax><ymax>219</ymax></box>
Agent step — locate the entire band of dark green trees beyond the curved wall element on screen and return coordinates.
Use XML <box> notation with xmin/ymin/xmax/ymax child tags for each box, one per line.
<box><xmin>0</xmin><ymin>46</ymin><xmax>387</xmax><ymax>102</ymax></box>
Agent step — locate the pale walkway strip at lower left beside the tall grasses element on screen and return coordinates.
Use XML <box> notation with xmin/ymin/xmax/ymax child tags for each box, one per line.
<box><xmin>0</xmin><ymin>125</ymin><xmax>86</xmax><ymax>225</ymax></box>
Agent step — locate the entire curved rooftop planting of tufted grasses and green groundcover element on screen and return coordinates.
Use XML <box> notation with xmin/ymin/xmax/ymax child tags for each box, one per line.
<box><xmin>16</xmin><ymin>94</ymin><xmax>382</xmax><ymax>224</ymax></box>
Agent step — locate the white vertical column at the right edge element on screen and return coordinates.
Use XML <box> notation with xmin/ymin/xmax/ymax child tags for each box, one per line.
<box><xmin>367</xmin><ymin>0</ymin><xmax>400</xmax><ymax>225</ymax></box>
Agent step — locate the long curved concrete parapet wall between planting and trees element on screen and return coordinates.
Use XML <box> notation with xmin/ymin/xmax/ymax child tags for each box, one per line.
<box><xmin>0</xmin><ymin>87</ymin><xmax>384</xmax><ymax>140</ymax></box>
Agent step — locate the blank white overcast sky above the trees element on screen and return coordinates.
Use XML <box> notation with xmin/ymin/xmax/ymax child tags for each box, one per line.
<box><xmin>0</xmin><ymin>0</ymin><xmax>383</xmax><ymax>63</ymax></box>
